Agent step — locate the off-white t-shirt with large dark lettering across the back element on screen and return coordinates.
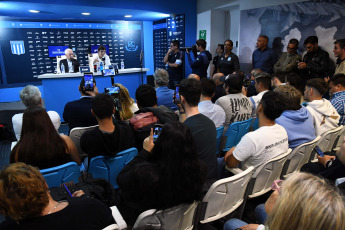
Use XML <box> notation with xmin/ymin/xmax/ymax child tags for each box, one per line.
<box><xmin>215</xmin><ymin>93</ymin><xmax>253</xmax><ymax>133</ymax></box>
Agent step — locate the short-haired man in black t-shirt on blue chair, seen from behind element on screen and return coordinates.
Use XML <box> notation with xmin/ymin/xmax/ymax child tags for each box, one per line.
<box><xmin>80</xmin><ymin>93</ymin><xmax>135</xmax><ymax>160</ymax></box>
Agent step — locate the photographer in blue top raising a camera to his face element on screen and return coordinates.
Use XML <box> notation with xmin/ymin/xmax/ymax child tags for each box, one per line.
<box><xmin>185</xmin><ymin>39</ymin><xmax>212</xmax><ymax>79</ymax></box>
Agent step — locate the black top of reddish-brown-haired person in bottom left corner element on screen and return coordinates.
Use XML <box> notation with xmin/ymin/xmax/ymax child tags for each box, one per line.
<box><xmin>0</xmin><ymin>198</ymin><xmax>115</xmax><ymax>230</ymax></box>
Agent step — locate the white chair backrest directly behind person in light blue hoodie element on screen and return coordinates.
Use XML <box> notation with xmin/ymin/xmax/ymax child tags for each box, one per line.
<box><xmin>281</xmin><ymin>136</ymin><xmax>320</xmax><ymax>178</ymax></box>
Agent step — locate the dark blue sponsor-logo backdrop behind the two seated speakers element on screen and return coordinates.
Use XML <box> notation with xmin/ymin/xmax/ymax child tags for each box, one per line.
<box><xmin>0</xmin><ymin>21</ymin><xmax>142</xmax><ymax>85</ymax></box>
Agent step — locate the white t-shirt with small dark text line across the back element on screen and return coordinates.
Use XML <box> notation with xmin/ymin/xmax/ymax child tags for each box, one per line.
<box><xmin>233</xmin><ymin>124</ymin><xmax>289</xmax><ymax>170</ymax></box>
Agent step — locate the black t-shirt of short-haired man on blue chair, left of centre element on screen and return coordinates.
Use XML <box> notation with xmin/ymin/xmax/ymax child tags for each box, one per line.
<box><xmin>80</xmin><ymin>121</ymin><xmax>135</xmax><ymax>159</ymax></box>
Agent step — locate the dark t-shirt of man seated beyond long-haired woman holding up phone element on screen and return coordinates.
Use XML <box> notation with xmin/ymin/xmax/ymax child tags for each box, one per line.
<box><xmin>184</xmin><ymin>113</ymin><xmax>218</xmax><ymax>179</ymax></box>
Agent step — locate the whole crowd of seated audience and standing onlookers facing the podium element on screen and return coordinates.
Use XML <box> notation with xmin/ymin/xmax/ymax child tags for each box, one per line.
<box><xmin>0</xmin><ymin>35</ymin><xmax>345</xmax><ymax>230</ymax></box>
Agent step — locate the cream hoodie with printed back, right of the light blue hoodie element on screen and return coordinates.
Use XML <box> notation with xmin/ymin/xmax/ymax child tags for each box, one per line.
<box><xmin>307</xmin><ymin>99</ymin><xmax>340</xmax><ymax>136</ymax></box>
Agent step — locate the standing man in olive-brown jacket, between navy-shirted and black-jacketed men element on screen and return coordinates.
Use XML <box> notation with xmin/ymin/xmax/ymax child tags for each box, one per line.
<box><xmin>273</xmin><ymin>38</ymin><xmax>302</xmax><ymax>73</ymax></box>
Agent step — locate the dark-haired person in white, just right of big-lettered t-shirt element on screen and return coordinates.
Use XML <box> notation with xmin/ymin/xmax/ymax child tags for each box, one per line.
<box><xmin>243</xmin><ymin>72</ymin><xmax>271</xmax><ymax>118</ymax></box>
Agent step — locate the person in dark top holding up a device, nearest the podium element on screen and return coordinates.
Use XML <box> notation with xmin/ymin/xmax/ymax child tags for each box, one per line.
<box><xmin>62</xmin><ymin>78</ymin><xmax>98</xmax><ymax>134</ymax></box>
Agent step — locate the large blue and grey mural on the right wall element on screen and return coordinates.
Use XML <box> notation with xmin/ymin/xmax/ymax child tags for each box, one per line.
<box><xmin>239</xmin><ymin>0</ymin><xmax>345</xmax><ymax>67</ymax></box>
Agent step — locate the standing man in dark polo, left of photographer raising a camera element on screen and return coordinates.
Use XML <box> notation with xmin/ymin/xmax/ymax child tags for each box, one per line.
<box><xmin>163</xmin><ymin>40</ymin><xmax>183</xmax><ymax>90</ymax></box>
